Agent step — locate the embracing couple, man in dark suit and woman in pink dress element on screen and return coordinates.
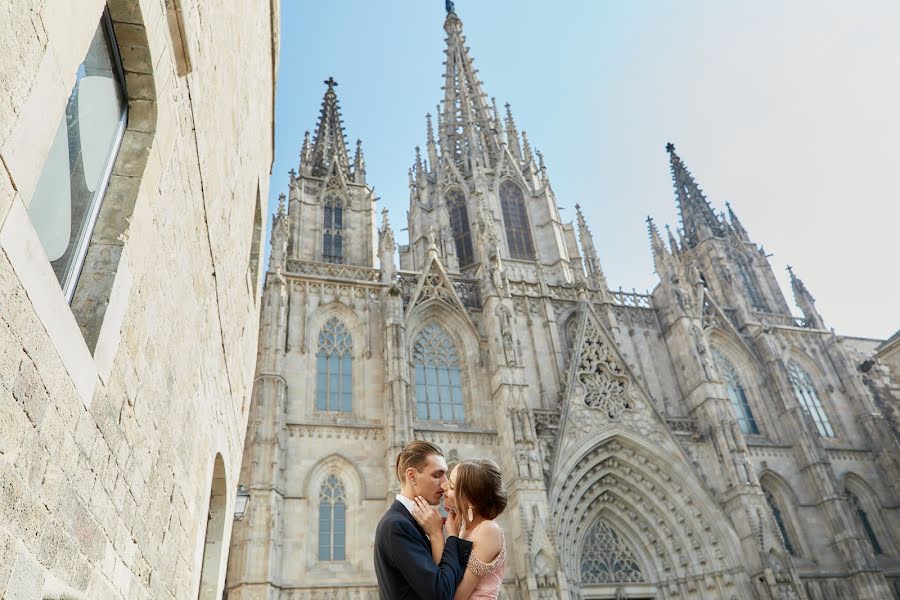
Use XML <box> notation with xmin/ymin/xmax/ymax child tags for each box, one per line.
<box><xmin>375</xmin><ymin>440</ymin><xmax>506</xmax><ymax>600</ymax></box>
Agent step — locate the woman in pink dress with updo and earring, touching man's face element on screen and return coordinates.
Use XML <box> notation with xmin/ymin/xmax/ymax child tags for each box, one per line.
<box><xmin>413</xmin><ymin>458</ymin><xmax>506</xmax><ymax>600</ymax></box>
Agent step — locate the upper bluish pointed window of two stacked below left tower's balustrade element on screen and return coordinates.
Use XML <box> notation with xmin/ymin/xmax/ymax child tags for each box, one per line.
<box><xmin>316</xmin><ymin>317</ymin><xmax>353</xmax><ymax>412</ymax></box>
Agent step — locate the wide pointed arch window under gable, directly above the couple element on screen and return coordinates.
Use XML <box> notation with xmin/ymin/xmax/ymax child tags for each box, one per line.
<box><xmin>413</xmin><ymin>323</ymin><xmax>465</xmax><ymax>421</ymax></box>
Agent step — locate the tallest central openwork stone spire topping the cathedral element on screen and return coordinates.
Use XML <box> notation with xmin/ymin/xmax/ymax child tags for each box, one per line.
<box><xmin>438</xmin><ymin>7</ymin><xmax>501</xmax><ymax>172</ymax></box>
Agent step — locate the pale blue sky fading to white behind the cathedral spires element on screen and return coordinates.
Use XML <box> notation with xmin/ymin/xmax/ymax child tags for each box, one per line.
<box><xmin>269</xmin><ymin>0</ymin><xmax>900</xmax><ymax>339</ymax></box>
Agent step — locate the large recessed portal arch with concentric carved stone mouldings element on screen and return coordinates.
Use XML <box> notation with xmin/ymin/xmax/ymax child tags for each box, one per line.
<box><xmin>550</xmin><ymin>428</ymin><xmax>749</xmax><ymax>598</ymax></box>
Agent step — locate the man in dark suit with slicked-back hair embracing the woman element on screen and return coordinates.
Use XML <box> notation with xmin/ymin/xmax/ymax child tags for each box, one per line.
<box><xmin>375</xmin><ymin>440</ymin><xmax>472</xmax><ymax>600</ymax></box>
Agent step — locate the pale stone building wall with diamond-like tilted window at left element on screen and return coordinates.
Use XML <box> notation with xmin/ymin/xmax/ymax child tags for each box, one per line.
<box><xmin>0</xmin><ymin>0</ymin><xmax>278</xmax><ymax>600</ymax></box>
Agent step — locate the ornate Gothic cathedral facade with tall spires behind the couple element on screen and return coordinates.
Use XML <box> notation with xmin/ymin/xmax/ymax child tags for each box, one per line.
<box><xmin>226</xmin><ymin>5</ymin><xmax>900</xmax><ymax>600</ymax></box>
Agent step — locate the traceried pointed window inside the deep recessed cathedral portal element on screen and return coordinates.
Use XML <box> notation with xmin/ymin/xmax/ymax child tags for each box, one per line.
<box><xmin>581</xmin><ymin>520</ymin><xmax>645</xmax><ymax>584</ymax></box>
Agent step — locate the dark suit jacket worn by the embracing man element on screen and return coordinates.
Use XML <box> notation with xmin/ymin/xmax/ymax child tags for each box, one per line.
<box><xmin>375</xmin><ymin>500</ymin><xmax>472</xmax><ymax>600</ymax></box>
